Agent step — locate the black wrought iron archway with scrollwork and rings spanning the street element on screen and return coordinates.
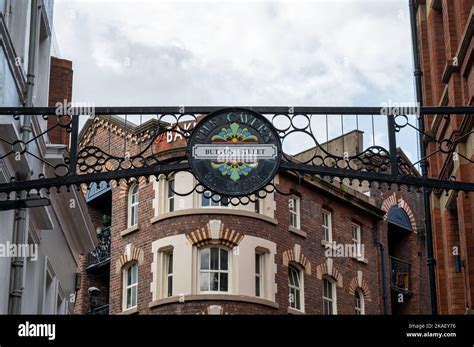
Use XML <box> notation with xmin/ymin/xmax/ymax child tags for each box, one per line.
<box><xmin>0</xmin><ymin>106</ymin><xmax>474</xmax><ymax>204</ymax></box>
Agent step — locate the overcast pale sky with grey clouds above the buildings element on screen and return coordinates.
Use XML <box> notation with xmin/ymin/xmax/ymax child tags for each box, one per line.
<box><xmin>54</xmin><ymin>0</ymin><xmax>416</xmax><ymax>162</ymax></box>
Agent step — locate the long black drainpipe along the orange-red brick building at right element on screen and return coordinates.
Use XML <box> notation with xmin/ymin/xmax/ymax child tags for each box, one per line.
<box><xmin>410</xmin><ymin>0</ymin><xmax>438</xmax><ymax>315</ymax></box>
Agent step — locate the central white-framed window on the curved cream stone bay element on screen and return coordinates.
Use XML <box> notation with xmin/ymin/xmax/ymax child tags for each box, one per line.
<box><xmin>199</xmin><ymin>247</ymin><xmax>229</xmax><ymax>292</ymax></box>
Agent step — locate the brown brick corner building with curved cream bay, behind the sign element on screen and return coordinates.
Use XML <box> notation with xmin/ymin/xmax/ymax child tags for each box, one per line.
<box><xmin>76</xmin><ymin>116</ymin><xmax>428</xmax><ymax>314</ymax></box>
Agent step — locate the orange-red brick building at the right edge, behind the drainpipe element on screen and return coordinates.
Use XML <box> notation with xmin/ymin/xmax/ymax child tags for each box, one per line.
<box><xmin>417</xmin><ymin>0</ymin><xmax>474</xmax><ymax>314</ymax></box>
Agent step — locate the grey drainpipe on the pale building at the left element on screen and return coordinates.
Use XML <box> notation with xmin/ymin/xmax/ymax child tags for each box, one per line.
<box><xmin>8</xmin><ymin>0</ymin><xmax>40</xmax><ymax>314</ymax></box>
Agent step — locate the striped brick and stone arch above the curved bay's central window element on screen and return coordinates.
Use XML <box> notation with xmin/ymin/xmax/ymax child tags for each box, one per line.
<box><xmin>186</xmin><ymin>220</ymin><xmax>244</xmax><ymax>248</ymax></box>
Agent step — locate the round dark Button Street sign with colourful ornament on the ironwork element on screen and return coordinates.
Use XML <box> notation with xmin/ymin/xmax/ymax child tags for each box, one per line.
<box><xmin>187</xmin><ymin>108</ymin><xmax>281</xmax><ymax>196</ymax></box>
